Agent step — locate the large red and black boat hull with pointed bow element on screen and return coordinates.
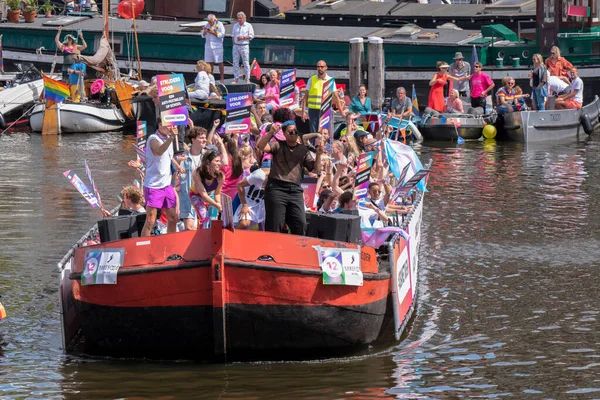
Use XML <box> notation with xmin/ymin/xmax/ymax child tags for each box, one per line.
<box><xmin>59</xmin><ymin>193</ymin><xmax>423</xmax><ymax>360</ymax></box>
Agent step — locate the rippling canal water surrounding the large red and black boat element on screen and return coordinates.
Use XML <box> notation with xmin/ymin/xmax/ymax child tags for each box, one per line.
<box><xmin>0</xmin><ymin>133</ymin><xmax>600</xmax><ymax>399</ymax></box>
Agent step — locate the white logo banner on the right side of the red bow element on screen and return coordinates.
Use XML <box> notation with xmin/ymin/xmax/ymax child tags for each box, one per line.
<box><xmin>314</xmin><ymin>246</ymin><xmax>363</xmax><ymax>286</ymax></box>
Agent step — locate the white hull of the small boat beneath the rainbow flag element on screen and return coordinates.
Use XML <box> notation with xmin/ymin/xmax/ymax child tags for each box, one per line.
<box><xmin>29</xmin><ymin>102</ymin><xmax>129</xmax><ymax>133</ymax></box>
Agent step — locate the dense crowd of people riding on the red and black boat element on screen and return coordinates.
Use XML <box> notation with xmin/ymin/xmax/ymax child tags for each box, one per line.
<box><xmin>106</xmin><ymin>60</ymin><xmax>413</xmax><ymax>239</ymax></box>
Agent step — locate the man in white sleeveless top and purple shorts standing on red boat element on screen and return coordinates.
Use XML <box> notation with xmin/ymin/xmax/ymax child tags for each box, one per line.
<box><xmin>142</xmin><ymin>119</ymin><xmax>178</xmax><ymax>236</ymax></box>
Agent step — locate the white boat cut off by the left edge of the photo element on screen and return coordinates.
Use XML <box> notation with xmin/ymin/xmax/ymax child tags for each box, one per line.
<box><xmin>0</xmin><ymin>64</ymin><xmax>44</xmax><ymax>129</ymax></box>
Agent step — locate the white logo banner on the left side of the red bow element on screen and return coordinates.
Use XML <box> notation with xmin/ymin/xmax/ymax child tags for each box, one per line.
<box><xmin>81</xmin><ymin>249</ymin><xmax>125</xmax><ymax>285</ymax></box>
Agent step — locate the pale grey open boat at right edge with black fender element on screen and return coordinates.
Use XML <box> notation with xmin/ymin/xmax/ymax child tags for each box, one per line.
<box><xmin>496</xmin><ymin>96</ymin><xmax>600</xmax><ymax>143</ymax></box>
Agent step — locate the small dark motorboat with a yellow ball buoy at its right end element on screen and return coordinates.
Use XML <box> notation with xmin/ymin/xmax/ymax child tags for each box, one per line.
<box><xmin>419</xmin><ymin>111</ymin><xmax>497</xmax><ymax>140</ymax></box>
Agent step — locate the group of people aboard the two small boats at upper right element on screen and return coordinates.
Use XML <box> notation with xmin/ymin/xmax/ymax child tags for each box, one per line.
<box><xmin>424</xmin><ymin>46</ymin><xmax>583</xmax><ymax>114</ymax></box>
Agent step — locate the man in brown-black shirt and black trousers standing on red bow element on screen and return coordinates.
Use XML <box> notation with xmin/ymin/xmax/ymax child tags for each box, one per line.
<box><xmin>256</xmin><ymin>120</ymin><xmax>323</xmax><ymax>235</ymax></box>
